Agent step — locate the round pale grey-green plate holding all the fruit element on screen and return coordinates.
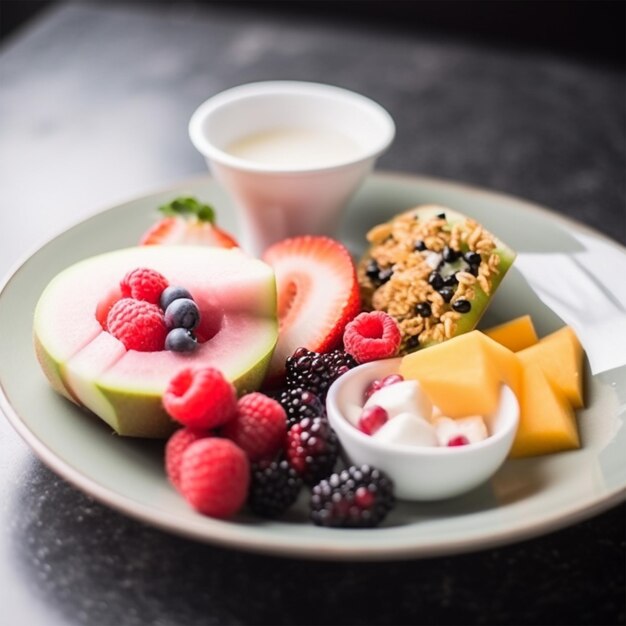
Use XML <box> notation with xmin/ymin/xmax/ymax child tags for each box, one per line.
<box><xmin>0</xmin><ymin>174</ymin><xmax>626</xmax><ymax>560</ymax></box>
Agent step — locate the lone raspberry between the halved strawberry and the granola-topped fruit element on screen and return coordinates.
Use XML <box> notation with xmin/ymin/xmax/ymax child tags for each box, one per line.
<box><xmin>343</xmin><ymin>311</ymin><xmax>402</xmax><ymax>363</ymax></box>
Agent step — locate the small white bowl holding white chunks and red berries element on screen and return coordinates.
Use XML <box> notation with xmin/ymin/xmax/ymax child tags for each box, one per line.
<box><xmin>326</xmin><ymin>358</ymin><xmax>519</xmax><ymax>500</ymax></box>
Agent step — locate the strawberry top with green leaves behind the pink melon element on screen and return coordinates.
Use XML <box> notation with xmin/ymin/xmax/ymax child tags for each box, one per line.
<box><xmin>139</xmin><ymin>197</ymin><xmax>239</xmax><ymax>248</ymax></box>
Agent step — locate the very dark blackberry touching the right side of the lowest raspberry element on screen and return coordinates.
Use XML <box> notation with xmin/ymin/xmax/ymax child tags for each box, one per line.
<box><xmin>248</xmin><ymin>459</ymin><xmax>302</xmax><ymax>518</ymax></box>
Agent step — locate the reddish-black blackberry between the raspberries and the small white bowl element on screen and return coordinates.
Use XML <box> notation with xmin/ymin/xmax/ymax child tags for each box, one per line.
<box><xmin>286</xmin><ymin>417</ymin><xmax>339</xmax><ymax>485</ymax></box>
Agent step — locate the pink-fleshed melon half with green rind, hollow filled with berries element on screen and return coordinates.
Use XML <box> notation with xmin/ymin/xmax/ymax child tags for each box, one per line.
<box><xmin>34</xmin><ymin>246</ymin><xmax>278</xmax><ymax>437</ymax></box>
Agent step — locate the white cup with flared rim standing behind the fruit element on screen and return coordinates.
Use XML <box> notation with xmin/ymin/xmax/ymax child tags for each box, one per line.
<box><xmin>189</xmin><ymin>81</ymin><xmax>395</xmax><ymax>254</ymax></box>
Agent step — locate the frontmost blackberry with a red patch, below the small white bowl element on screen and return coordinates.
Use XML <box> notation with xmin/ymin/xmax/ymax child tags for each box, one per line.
<box><xmin>311</xmin><ymin>465</ymin><xmax>395</xmax><ymax>528</ymax></box>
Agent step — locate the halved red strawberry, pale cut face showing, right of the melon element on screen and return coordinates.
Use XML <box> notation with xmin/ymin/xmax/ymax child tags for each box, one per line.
<box><xmin>263</xmin><ymin>235</ymin><xmax>360</xmax><ymax>382</ymax></box>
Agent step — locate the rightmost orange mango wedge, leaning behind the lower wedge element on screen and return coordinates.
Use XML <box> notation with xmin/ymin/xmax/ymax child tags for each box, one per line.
<box><xmin>519</xmin><ymin>326</ymin><xmax>584</xmax><ymax>409</ymax></box>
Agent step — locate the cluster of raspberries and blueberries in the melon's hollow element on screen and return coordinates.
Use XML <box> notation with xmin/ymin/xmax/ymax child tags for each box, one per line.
<box><xmin>106</xmin><ymin>267</ymin><xmax>200</xmax><ymax>352</ymax></box>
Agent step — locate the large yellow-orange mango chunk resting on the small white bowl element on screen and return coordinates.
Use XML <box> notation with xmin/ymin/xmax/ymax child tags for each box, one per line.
<box><xmin>399</xmin><ymin>330</ymin><xmax>522</xmax><ymax>418</ymax></box>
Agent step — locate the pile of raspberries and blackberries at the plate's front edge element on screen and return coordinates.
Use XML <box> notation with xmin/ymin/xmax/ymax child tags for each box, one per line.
<box><xmin>163</xmin><ymin>360</ymin><xmax>392</xmax><ymax>526</ymax></box>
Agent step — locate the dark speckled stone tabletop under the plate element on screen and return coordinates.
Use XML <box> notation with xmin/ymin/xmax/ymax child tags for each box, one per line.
<box><xmin>0</xmin><ymin>3</ymin><xmax>626</xmax><ymax>626</ymax></box>
